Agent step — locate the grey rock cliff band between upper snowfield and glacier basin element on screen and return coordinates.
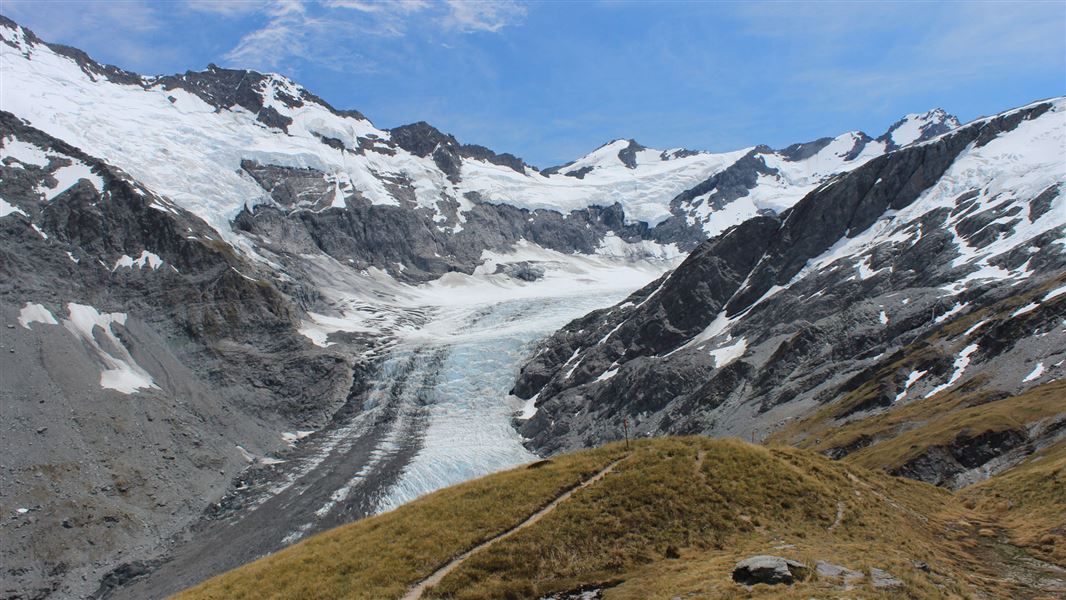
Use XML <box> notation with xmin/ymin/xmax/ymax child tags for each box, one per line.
<box><xmin>235</xmin><ymin>195</ymin><xmax>647</xmax><ymax>281</ymax></box>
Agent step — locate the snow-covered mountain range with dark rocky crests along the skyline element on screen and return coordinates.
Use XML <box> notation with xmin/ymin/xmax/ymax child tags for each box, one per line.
<box><xmin>0</xmin><ymin>15</ymin><xmax>957</xmax><ymax>279</ymax></box>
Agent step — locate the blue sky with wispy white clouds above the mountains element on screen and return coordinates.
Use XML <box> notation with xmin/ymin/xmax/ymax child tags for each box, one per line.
<box><xmin>0</xmin><ymin>0</ymin><xmax>1066</xmax><ymax>167</ymax></box>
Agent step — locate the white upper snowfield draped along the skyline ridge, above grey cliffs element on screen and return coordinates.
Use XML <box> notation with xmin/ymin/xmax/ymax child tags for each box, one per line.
<box><xmin>0</xmin><ymin>19</ymin><xmax>957</xmax><ymax>249</ymax></box>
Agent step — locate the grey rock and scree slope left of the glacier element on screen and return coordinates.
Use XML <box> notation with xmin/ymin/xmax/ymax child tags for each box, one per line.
<box><xmin>0</xmin><ymin>113</ymin><xmax>362</xmax><ymax>597</ymax></box>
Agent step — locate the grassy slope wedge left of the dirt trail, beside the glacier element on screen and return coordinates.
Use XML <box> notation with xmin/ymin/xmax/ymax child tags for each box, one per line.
<box><xmin>175</xmin><ymin>444</ymin><xmax>620</xmax><ymax>600</ymax></box>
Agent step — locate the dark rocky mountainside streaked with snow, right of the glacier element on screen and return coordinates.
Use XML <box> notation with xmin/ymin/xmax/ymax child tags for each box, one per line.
<box><xmin>514</xmin><ymin>101</ymin><xmax>1066</xmax><ymax>458</ymax></box>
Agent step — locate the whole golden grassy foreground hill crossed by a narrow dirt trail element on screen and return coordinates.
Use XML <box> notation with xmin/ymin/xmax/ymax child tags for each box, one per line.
<box><xmin>178</xmin><ymin>437</ymin><xmax>1057</xmax><ymax>600</ymax></box>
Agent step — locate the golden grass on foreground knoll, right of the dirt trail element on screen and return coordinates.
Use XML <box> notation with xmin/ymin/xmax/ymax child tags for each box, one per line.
<box><xmin>426</xmin><ymin>438</ymin><xmax>1036</xmax><ymax>600</ymax></box>
